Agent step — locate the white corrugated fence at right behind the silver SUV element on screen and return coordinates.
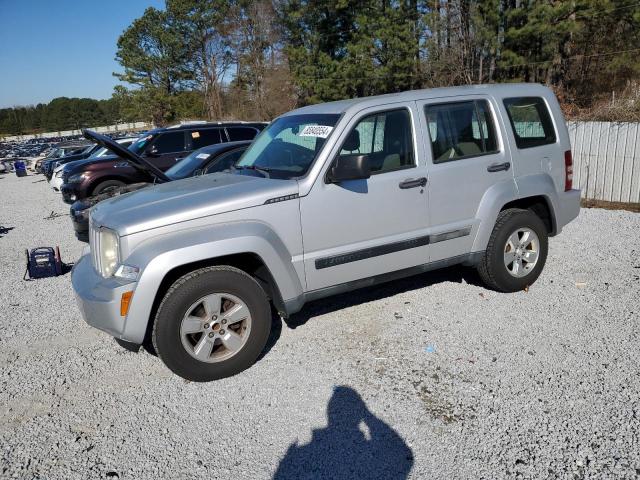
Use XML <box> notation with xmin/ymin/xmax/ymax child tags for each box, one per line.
<box><xmin>568</xmin><ymin>122</ymin><xmax>640</xmax><ymax>203</ymax></box>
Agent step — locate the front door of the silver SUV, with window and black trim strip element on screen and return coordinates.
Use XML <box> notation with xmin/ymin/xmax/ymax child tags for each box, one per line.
<box><xmin>300</xmin><ymin>102</ymin><xmax>429</xmax><ymax>291</ymax></box>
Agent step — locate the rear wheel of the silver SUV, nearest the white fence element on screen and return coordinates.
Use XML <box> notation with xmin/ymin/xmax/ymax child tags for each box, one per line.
<box><xmin>477</xmin><ymin>208</ymin><xmax>549</xmax><ymax>292</ymax></box>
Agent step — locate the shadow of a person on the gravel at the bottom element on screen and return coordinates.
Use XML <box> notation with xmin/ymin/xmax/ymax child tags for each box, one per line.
<box><xmin>273</xmin><ymin>386</ymin><xmax>413</xmax><ymax>480</ymax></box>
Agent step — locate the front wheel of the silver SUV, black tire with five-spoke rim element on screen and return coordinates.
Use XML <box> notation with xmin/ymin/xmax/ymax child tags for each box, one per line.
<box><xmin>151</xmin><ymin>266</ymin><xmax>271</xmax><ymax>382</ymax></box>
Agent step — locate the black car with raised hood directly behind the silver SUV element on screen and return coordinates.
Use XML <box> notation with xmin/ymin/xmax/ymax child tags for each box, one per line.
<box><xmin>70</xmin><ymin>141</ymin><xmax>251</xmax><ymax>243</ymax></box>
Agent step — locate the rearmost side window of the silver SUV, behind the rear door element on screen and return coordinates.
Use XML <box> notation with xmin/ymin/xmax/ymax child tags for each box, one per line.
<box><xmin>504</xmin><ymin>97</ymin><xmax>556</xmax><ymax>148</ymax></box>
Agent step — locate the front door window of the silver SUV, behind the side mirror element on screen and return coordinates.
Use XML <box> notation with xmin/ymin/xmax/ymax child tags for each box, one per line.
<box><xmin>340</xmin><ymin>109</ymin><xmax>414</xmax><ymax>173</ymax></box>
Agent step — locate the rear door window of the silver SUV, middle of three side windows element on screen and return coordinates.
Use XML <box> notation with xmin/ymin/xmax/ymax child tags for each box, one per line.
<box><xmin>425</xmin><ymin>100</ymin><xmax>498</xmax><ymax>163</ymax></box>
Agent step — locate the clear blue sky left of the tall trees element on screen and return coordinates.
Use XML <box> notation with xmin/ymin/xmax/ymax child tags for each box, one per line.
<box><xmin>0</xmin><ymin>0</ymin><xmax>164</xmax><ymax>108</ymax></box>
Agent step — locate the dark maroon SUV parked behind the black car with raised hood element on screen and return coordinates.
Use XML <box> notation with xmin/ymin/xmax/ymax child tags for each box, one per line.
<box><xmin>61</xmin><ymin>122</ymin><xmax>266</xmax><ymax>204</ymax></box>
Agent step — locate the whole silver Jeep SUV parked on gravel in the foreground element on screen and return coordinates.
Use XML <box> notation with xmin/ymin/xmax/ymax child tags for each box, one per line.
<box><xmin>72</xmin><ymin>84</ymin><xmax>580</xmax><ymax>381</ymax></box>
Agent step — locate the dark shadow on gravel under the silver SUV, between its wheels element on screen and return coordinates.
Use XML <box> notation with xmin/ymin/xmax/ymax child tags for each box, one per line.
<box><xmin>285</xmin><ymin>265</ymin><xmax>482</xmax><ymax>329</ymax></box>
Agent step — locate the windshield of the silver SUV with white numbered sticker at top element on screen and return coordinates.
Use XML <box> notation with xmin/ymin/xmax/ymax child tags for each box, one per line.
<box><xmin>236</xmin><ymin>114</ymin><xmax>340</xmax><ymax>179</ymax></box>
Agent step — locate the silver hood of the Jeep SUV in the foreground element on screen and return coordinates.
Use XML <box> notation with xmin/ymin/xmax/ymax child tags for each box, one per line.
<box><xmin>91</xmin><ymin>173</ymin><xmax>298</xmax><ymax>236</ymax></box>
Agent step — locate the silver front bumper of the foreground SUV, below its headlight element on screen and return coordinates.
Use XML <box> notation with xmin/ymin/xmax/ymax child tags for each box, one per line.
<box><xmin>71</xmin><ymin>254</ymin><xmax>143</xmax><ymax>344</ymax></box>
